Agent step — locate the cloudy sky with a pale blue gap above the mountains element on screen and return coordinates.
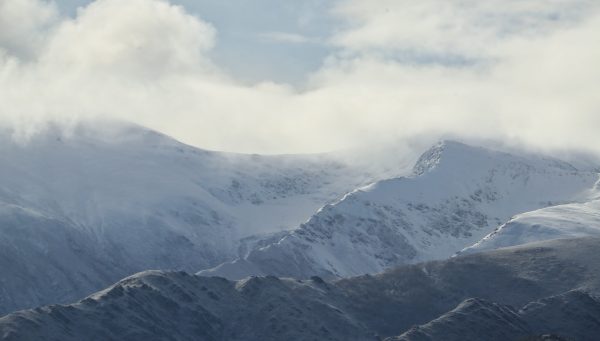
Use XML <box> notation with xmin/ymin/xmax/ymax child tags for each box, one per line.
<box><xmin>0</xmin><ymin>0</ymin><xmax>600</xmax><ymax>153</ymax></box>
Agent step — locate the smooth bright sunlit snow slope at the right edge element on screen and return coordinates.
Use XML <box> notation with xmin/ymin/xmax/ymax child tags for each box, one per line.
<box><xmin>461</xmin><ymin>199</ymin><xmax>600</xmax><ymax>253</ymax></box>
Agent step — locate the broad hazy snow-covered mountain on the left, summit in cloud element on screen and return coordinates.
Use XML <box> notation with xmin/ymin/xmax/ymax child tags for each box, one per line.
<box><xmin>0</xmin><ymin>122</ymin><xmax>394</xmax><ymax>313</ymax></box>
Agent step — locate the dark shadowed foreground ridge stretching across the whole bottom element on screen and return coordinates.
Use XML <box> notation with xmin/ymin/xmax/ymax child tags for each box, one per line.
<box><xmin>0</xmin><ymin>239</ymin><xmax>600</xmax><ymax>341</ymax></box>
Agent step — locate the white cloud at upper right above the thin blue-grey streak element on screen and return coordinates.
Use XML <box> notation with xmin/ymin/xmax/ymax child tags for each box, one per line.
<box><xmin>332</xmin><ymin>0</ymin><xmax>599</xmax><ymax>58</ymax></box>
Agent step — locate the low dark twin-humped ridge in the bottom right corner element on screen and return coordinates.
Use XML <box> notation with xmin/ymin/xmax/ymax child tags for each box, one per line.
<box><xmin>386</xmin><ymin>291</ymin><xmax>600</xmax><ymax>341</ymax></box>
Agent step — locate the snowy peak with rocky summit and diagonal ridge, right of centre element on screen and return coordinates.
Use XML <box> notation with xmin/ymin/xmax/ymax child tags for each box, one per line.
<box><xmin>200</xmin><ymin>141</ymin><xmax>598</xmax><ymax>279</ymax></box>
